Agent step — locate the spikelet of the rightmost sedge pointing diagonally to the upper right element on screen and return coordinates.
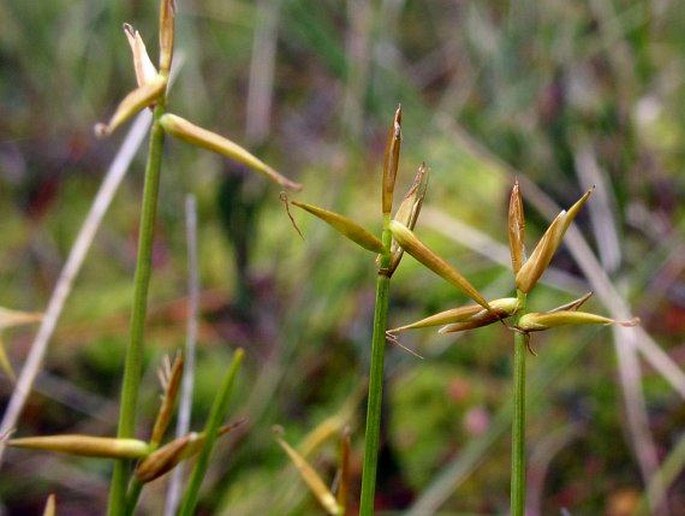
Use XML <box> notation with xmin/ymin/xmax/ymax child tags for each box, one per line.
<box><xmin>516</xmin><ymin>188</ymin><xmax>594</xmax><ymax>294</ymax></box>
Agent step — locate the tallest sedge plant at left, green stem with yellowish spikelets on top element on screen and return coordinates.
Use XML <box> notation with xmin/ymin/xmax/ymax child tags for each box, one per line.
<box><xmin>95</xmin><ymin>0</ymin><xmax>300</xmax><ymax>515</ymax></box>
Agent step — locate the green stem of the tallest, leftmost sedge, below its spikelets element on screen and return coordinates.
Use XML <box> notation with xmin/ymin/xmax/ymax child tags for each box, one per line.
<box><xmin>108</xmin><ymin>102</ymin><xmax>164</xmax><ymax>516</ymax></box>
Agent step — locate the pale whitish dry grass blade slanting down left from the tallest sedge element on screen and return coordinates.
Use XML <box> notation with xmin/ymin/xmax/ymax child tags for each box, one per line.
<box><xmin>0</xmin><ymin>110</ymin><xmax>152</xmax><ymax>464</ymax></box>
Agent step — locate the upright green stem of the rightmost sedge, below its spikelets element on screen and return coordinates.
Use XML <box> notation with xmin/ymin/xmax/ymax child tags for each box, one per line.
<box><xmin>511</xmin><ymin>292</ymin><xmax>528</xmax><ymax>516</ymax></box>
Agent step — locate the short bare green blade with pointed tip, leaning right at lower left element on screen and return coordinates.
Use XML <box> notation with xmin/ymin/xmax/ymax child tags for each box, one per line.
<box><xmin>178</xmin><ymin>348</ymin><xmax>245</xmax><ymax>516</ymax></box>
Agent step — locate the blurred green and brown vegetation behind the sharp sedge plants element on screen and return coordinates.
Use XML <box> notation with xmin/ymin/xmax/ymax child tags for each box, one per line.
<box><xmin>0</xmin><ymin>0</ymin><xmax>685</xmax><ymax>515</ymax></box>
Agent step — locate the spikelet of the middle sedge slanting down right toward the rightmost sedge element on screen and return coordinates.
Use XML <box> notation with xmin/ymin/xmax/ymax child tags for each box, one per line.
<box><xmin>389</xmin><ymin>220</ymin><xmax>490</xmax><ymax>310</ymax></box>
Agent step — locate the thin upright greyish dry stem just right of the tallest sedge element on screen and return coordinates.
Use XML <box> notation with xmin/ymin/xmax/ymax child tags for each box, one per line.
<box><xmin>164</xmin><ymin>195</ymin><xmax>200</xmax><ymax>516</ymax></box>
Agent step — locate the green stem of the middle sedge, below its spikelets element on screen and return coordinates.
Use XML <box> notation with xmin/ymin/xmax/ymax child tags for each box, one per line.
<box><xmin>359</xmin><ymin>225</ymin><xmax>392</xmax><ymax>516</ymax></box>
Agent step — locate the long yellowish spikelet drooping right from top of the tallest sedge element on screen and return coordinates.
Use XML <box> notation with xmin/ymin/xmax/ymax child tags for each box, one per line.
<box><xmin>159</xmin><ymin>113</ymin><xmax>302</xmax><ymax>190</ymax></box>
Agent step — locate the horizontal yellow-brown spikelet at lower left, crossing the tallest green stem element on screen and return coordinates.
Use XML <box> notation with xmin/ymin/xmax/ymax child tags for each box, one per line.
<box><xmin>7</xmin><ymin>434</ymin><xmax>150</xmax><ymax>459</ymax></box>
